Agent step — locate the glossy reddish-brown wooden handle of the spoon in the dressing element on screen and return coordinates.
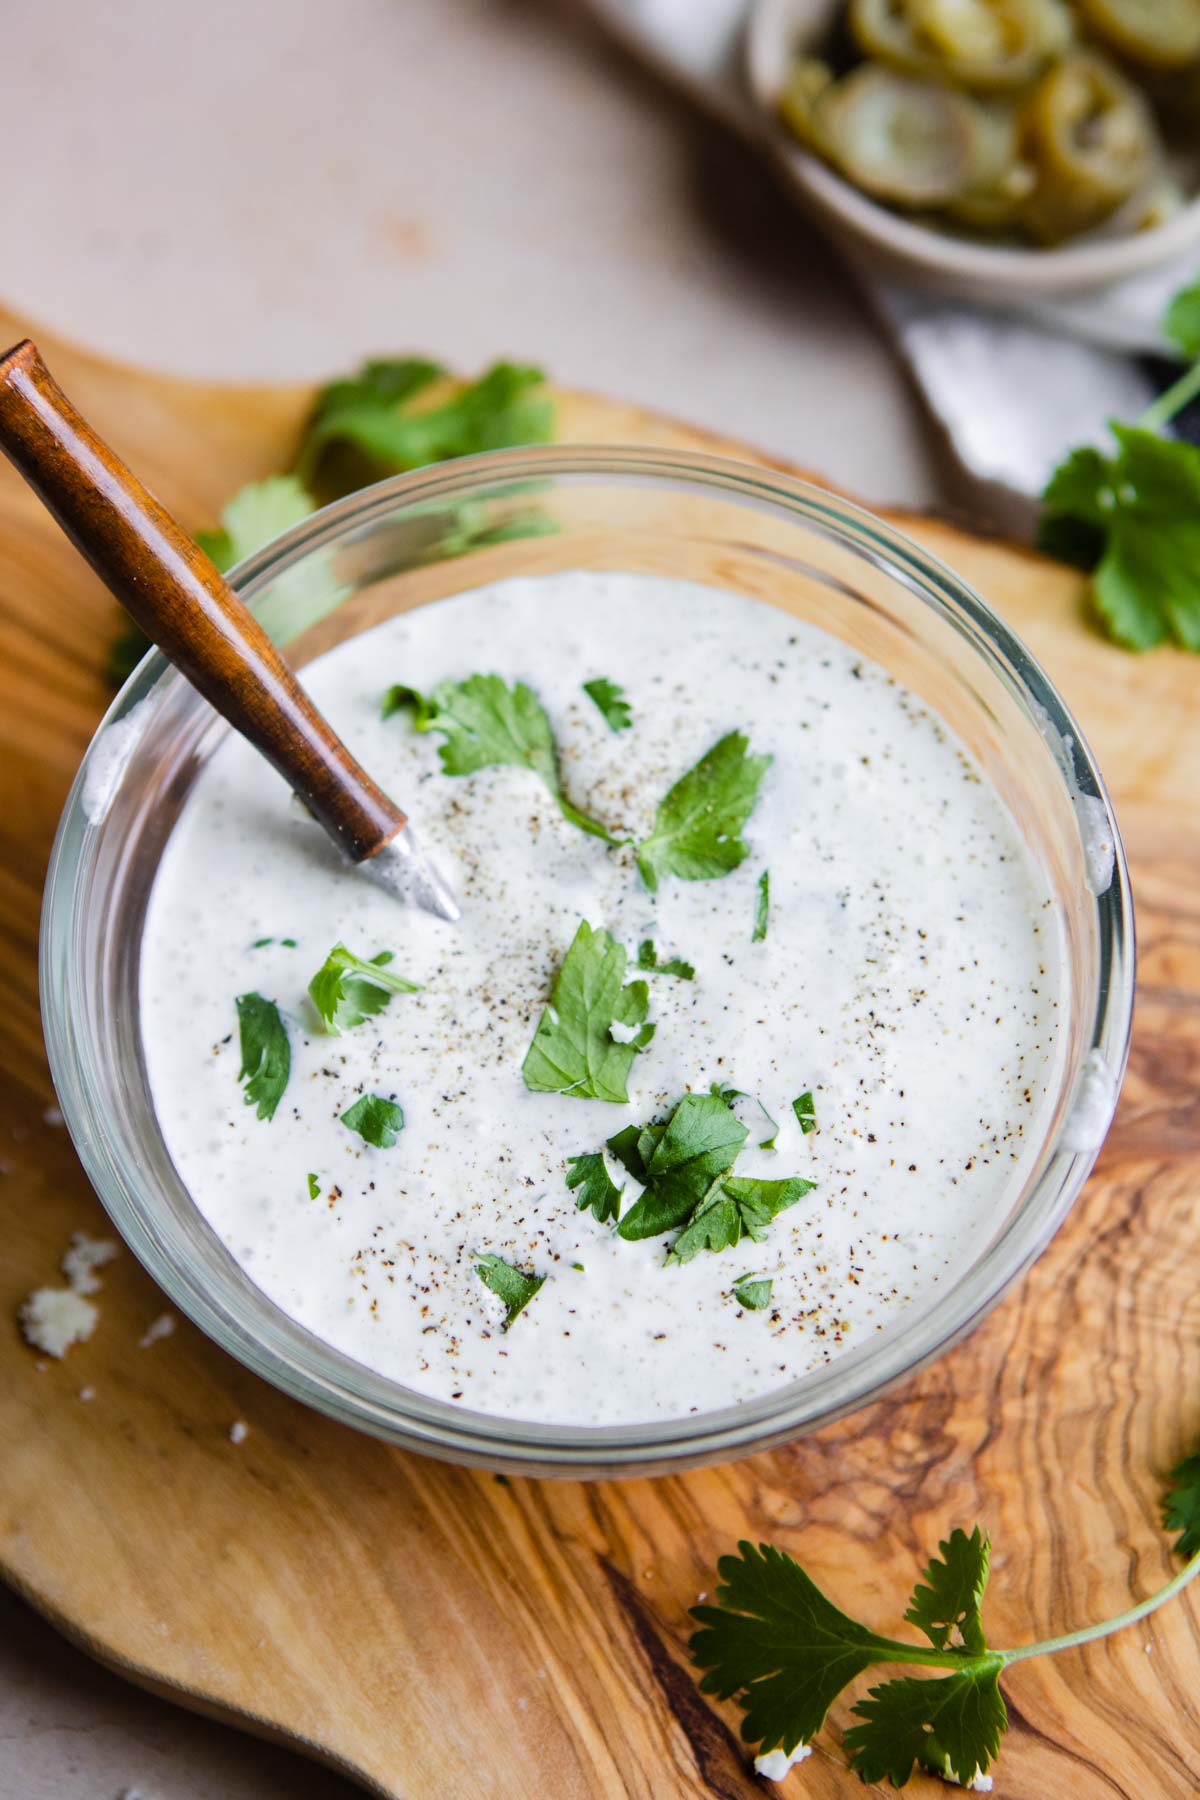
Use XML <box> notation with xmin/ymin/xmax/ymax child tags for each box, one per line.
<box><xmin>0</xmin><ymin>338</ymin><xmax>405</xmax><ymax>862</ymax></box>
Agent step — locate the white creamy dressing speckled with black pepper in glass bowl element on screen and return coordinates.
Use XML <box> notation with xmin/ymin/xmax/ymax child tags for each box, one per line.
<box><xmin>140</xmin><ymin>571</ymin><xmax>1060</xmax><ymax>1426</ymax></box>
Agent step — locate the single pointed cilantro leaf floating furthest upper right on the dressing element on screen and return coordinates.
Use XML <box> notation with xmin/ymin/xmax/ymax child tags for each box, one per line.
<box><xmin>637</xmin><ymin>731</ymin><xmax>772</xmax><ymax>893</ymax></box>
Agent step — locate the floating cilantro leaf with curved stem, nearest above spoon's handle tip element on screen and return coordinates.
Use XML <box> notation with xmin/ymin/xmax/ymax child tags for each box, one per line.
<box><xmin>383</xmin><ymin>675</ymin><xmax>615</xmax><ymax>844</ymax></box>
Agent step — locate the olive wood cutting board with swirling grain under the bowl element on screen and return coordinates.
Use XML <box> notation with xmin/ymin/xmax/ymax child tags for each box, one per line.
<box><xmin>0</xmin><ymin>302</ymin><xmax>1200</xmax><ymax>1800</ymax></box>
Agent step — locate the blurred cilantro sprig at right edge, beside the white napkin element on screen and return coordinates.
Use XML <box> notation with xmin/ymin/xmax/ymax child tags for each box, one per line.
<box><xmin>1038</xmin><ymin>283</ymin><xmax>1200</xmax><ymax>652</ymax></box>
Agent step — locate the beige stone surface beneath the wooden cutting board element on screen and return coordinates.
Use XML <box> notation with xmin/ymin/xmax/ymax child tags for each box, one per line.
<box><xmin>0</xmin><ymin>0</ymin><xmax>937</xmax><ymax>1800</ymax></box>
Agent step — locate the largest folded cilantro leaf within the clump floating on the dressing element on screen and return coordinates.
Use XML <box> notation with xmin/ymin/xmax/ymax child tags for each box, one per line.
<box><xmin>608</xmin><ymin>1094</ymin><xmax>747</xmax><ymax>1238</ymax></box>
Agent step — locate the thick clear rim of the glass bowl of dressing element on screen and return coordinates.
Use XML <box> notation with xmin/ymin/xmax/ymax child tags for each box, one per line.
<box><xmin>41</xmin><ymin>445</ymin><xmax>1135</xmax><ymax>1476</ymax></box>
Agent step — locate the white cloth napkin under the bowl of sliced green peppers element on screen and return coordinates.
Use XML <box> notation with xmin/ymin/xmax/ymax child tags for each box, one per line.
<box><xmin>583</xmin><ymin>0</ymin><xmax>1196</xmax><ymax>531</ymax></box>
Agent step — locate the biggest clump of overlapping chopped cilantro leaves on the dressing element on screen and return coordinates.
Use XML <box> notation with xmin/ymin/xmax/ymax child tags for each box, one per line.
<box><xmin>608</xmin><ymin>1089</ymin><xmax>813</xmax><ymax>1262</ymax></box>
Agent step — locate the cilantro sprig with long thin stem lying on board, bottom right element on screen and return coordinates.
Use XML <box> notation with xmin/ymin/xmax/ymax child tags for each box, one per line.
<box><xmin>691</xmin><ymin>1490</ymin><xmax>1200</xmax><ymax>1787</ymax></box>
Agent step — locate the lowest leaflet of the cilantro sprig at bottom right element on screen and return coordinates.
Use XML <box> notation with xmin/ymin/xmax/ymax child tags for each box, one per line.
<box><xmin>842</xmin><ymin>1656</ymin><xmax>1007</xmax><ymax>1787</ymax></box>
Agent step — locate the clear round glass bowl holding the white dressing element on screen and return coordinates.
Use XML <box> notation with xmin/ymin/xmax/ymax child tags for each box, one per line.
<box><xmin>41</xmin><ymin>448</ymin><xmax>1133</xmax><ymax>1476</ymax></box>
